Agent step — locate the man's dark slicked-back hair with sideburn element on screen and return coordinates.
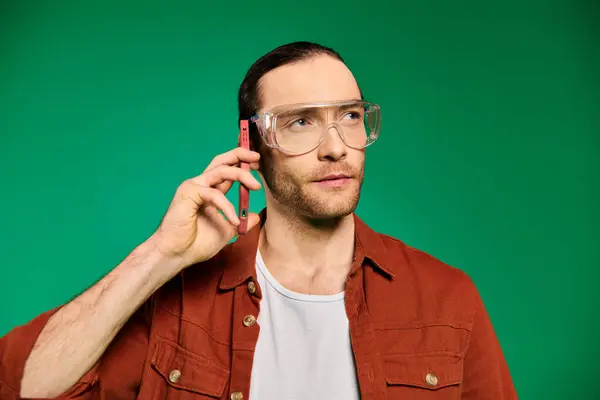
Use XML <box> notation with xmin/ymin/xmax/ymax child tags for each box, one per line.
<box><xmin>238</xmin><ymin>42</ymin><xmax>344</xmax><ymax>151</ymax></box>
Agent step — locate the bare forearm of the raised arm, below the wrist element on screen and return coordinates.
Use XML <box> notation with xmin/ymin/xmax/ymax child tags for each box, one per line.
<box><xmin>21</xmin><ymin>241</ymin><xmax>178</xmax><ymax>398</ymax></box>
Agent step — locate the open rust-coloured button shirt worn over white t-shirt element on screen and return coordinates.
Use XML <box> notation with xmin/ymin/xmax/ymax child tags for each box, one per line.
<box><xmin>0</xmin><ymin>213</ymin><xmax>517</xmax><ymax>400</ymax></box>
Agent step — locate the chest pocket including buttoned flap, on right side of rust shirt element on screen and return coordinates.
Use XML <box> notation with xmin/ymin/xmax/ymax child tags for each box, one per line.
<box><xmin>384</xmin><ymin>352</ymin><xmax>463</xmax><ymax>400</ymax></box>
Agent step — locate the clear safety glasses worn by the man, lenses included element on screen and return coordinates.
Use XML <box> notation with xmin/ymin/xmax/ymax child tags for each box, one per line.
<box><xmin>250</xmin><ymin>101</ymin><xmax>381</xmax><ymax>155</ymax></box>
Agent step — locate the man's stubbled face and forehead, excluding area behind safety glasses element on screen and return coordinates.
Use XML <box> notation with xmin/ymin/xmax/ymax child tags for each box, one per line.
<box><xmin>260</xmin><ymin>56</ymin><xmax>365</xmax><ymax>219</ymax></box>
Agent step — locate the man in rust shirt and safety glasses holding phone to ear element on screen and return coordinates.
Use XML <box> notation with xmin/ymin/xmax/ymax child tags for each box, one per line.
<box><xmin>0</xmin><ymin>42</ymin><xmax>516</xmax><ymax>400</ymax></box>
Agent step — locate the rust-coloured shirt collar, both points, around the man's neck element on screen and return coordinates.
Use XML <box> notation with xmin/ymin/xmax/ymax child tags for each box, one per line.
<box><xmin>219</xmin><ymin>208</ymin><xmax>394</xmax><ymax>290</ymax></box>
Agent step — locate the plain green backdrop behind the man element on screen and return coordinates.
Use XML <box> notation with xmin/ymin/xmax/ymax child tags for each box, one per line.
<box><xmin>0</xmin><ymin>0</ymin><xmax>600</xmax><ymax>399</ymax></box>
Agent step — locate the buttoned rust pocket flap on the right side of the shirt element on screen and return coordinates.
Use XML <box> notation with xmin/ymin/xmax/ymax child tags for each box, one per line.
<box><xmin>385</xmin><ymin>353</ymin><xmax>463</xmax><ymax>390</ymax></box>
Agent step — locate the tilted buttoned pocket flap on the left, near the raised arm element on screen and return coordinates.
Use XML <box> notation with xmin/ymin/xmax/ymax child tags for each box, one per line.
<box><xmin>152</xmin><ymin>339</ymin><xmax>230</xmax><ymax>398</ymax></box>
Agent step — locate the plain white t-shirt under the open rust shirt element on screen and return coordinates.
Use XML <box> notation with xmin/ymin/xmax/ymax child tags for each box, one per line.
<box><xmin>250</xmin><ymin>252</ymin><xmax>360</xmax><ymax>400</ymax></box>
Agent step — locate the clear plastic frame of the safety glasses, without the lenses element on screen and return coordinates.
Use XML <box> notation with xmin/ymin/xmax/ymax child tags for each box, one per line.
<box><xmin>248</xmin><ymin>100</ymin><xmax>381</xmax><ymax>155</ymax></box>
